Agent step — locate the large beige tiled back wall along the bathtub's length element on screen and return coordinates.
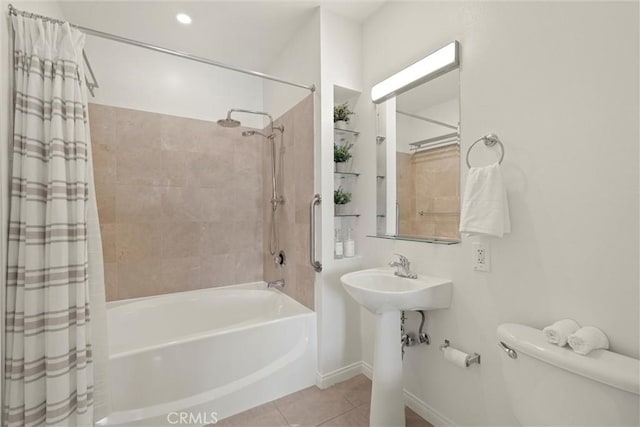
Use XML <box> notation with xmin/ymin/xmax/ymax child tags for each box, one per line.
<box><xmin>89</xmin><ymin>104</ymin><xmax>266</xmax><ymax>300</ymax></box>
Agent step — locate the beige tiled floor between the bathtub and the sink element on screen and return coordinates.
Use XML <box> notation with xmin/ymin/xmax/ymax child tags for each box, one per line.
<box><xmin>216</xmin><ymin>375</ymin><xmax>433</xmax><ymax>427</ymax></box>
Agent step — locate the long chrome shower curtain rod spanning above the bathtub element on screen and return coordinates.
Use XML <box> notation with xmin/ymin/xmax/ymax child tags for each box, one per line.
<box><xmin>9</xmin><ymin>4</ymin><xmax>316</xmax><ymax>92</ymax></box>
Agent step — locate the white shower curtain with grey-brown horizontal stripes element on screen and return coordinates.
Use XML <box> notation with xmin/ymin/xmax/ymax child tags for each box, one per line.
<box><xmin>3</xmin><ymin>16</ymin><xmax>108</xmax><ymax>426</ymax></box>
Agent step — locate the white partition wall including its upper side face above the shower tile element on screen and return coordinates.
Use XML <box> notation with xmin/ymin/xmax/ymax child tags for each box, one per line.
<box><xmin>264</xmin><ymin>8</ymin><xmax>362</xmax><ymax>385</ymax></box>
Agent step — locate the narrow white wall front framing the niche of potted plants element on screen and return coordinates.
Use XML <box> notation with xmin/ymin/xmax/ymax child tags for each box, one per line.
<box><xmin>316</xmin><ymin>8</ymin><xmax>362</xmax><ymax>380</ymax></box>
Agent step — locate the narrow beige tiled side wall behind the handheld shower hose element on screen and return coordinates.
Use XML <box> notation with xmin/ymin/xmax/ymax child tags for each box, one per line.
<box><xmin>262</xmin><ymin>95</ymin><xmax>314</xmax><ymax>309</ymax></box>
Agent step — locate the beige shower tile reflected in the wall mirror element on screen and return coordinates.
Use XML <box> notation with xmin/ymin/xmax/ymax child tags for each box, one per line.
<box><xmin>397</xmin><ymin>146</ymin><xmax>460</xmax><ymax>239</ymax></box>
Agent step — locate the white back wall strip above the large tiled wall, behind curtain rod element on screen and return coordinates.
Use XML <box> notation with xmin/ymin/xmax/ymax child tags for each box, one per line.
<box><xmin>86</xmin><ymin>36</ymin><xmax>264</xmax><ymax>128</ymax></box>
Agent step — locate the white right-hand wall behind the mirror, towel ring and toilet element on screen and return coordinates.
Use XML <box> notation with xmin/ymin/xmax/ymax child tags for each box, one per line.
<box><xmin>357</xmin><ymin>2</ymin><xmax>640</xmax><ymax>425</ymax></box>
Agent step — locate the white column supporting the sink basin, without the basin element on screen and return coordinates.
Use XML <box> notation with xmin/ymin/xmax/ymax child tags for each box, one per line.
<box><xmin>369</xmin><ymin>311</ymin><xmax>405</xmax><ymax>427</ymax></box>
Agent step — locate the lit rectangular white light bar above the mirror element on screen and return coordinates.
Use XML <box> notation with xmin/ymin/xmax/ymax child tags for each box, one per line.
<box><xmin>371</xmin><ymin>40</ymin><xmax>460</xmax><ymax>104</ymax></box>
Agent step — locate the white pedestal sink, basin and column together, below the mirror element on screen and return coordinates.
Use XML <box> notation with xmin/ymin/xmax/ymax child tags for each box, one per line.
<box><xmin>340</xmin><ymin>268</ymin><xmax>452</xmax><ymax>427</ymax></box>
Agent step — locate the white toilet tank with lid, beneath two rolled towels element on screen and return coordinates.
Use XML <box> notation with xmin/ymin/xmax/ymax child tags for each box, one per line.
<box><xmin>497</xmin><ymin>323</ymin><xmax>640</xmax><ymax>426</ymax></box>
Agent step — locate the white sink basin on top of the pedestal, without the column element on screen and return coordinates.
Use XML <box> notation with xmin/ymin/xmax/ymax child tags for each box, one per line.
<box><xmin>340</xmin><ymin>268</ymin><xmax>452</xmax><ymax>313</ymax></box>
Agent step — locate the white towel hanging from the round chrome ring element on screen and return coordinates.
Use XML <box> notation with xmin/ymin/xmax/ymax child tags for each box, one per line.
<box><xmin>460</xmin><ymin>163</ymin><xmax>511</xmax><ymax>237</ymax></box>
